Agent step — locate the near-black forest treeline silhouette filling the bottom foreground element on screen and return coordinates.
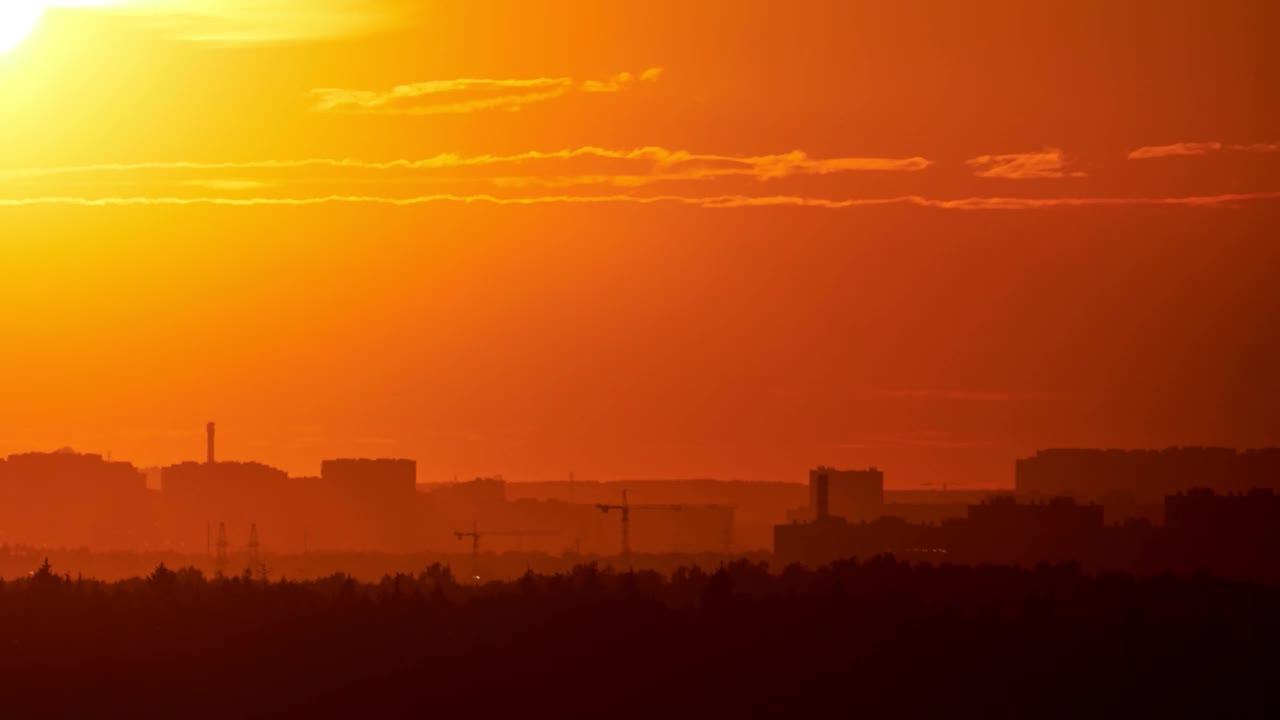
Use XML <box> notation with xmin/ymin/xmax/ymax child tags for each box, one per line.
<box><xmin>0</xmin><ymin>556</ymin><xmax>1280</xmax><ymax>717</ymax></box>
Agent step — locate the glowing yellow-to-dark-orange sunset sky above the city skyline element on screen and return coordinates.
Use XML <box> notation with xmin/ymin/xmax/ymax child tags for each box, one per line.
<box><xmin>0</xmin><ymin>0</ymin><xmax>1280</xmax><ymax>487</ymax></box>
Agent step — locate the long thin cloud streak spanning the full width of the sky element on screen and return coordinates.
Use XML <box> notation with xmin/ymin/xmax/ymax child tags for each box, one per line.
<box><xmin>0</xmin><ymin>191</ymin><xmax>1280</xmax><ymax>210</ymax></box>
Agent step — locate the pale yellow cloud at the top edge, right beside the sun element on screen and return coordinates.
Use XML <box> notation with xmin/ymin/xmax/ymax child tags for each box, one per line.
<box><xmin>50</xmin><ymin>0</ymin><xmax>422</xmax><ymax>46</ymax></box>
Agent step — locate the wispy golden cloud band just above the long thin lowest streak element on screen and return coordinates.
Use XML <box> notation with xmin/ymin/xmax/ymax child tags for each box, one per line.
<box><xmin>0</xmin><ymin>146</ymin><xmax>931</xmax><ymax>188</ymax></box>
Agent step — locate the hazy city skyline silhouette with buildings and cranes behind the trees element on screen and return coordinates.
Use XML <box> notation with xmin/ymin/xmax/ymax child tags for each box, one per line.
<box><xmin>0</xmin><ymin>421</ymin><xmax>1280</xmax><ymax>582</ymax></box>
